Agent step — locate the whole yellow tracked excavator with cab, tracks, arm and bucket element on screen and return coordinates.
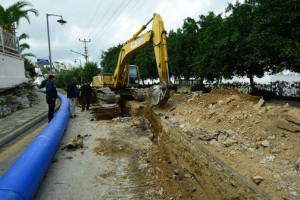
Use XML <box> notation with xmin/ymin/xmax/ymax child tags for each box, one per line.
<box><xmin>92</xmin><ymin>13</ymin><xmax>170</xmax><ymax>105</ymax></box>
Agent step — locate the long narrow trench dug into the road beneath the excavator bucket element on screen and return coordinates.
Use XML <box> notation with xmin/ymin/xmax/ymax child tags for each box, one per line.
<box><xmin>95</xmin><ymin>101</ymin><xmax>274</xmax><ymax>200</ymax></box>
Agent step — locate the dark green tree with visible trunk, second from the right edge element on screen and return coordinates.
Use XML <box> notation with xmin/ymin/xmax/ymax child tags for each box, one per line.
<box><xmin>224</xmin><ymin>3</ymin><xmax>268</xmax><ymax>90</ymax></box>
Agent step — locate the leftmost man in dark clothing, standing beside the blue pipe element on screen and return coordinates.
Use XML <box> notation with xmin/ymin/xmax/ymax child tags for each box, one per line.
<box><xmin>46</xmin><ymin>75</ymin><xmax>57</xmax><ymax>122</ymax></box>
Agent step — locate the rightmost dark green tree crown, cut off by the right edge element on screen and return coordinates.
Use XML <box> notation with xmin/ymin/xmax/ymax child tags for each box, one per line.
<box><xmin>253</xmin><ymin>0</ymin><xmax>300</xmax><ymax>73</ymax></box>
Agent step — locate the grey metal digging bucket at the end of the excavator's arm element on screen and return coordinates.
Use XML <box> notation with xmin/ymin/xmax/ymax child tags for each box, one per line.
<box><xmin>151</xmin><ymin>85</ymin><xmax>170</xmax><ymax>105</ymax></box>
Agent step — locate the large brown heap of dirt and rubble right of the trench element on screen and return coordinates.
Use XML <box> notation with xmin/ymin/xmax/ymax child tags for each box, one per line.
<box><xmin>153</xmin><ymin>89</ymin><xmax>300</xmax><ymax>199</ymax></box>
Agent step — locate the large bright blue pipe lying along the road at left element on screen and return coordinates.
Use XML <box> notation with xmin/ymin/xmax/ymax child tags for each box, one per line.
<box><xmin>0</xmin><ymin>91</ymin><xmax>70</xmax><ymax>200</ymax></box>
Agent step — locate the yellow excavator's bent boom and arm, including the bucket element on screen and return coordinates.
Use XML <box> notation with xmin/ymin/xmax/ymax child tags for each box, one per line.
<box><xmin>113</xmin><ymin>13</ymin><xmax>170</xmax><ymax>104</ymax></box>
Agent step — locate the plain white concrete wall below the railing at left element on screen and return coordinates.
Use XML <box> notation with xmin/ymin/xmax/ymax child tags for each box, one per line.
<box><xmin>0</xmin><ymin>52</ymin><xmax>28</xmax><ymax>90</ymax></box>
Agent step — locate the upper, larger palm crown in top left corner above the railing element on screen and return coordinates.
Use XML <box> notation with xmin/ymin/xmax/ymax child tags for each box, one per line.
<box><xmin>0</xmin><ymin>1</ymin><xmax>39</xmax><ymax>33</ymax></box>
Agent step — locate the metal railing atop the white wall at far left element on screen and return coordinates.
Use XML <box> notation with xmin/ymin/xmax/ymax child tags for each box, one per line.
<box><xmin>0</xmin><ymin>27</ymin><xmax>20</xmax><ymax>55</ymax></box>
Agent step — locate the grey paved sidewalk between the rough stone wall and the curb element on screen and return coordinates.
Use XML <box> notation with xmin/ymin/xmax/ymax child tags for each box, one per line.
<box><xmin>0</xmin><ymin>92</ymin><xmax>55</xmax><ymax>146</ymax></box>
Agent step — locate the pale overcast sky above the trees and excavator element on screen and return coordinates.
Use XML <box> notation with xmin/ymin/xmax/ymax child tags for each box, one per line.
<box><xmin>0</xmin><ymin>0</ymin><xmax>236</xmax><ymax>65</ymax></box>
